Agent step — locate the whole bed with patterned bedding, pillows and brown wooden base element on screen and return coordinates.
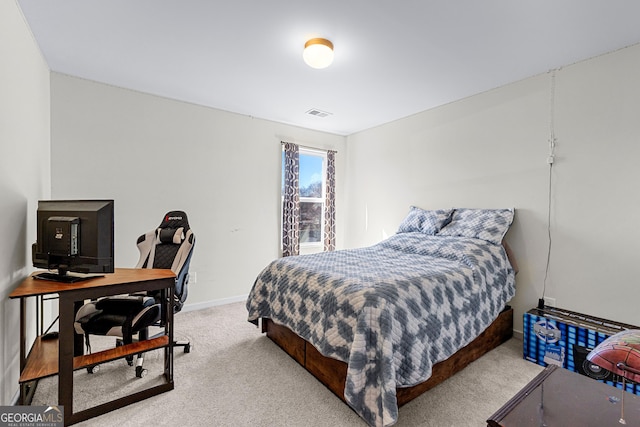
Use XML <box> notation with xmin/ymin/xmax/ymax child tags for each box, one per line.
<box><xmin>247</xmin><ymin>207</ymin><xmax>515</xmax><ymax>426</ymax></box>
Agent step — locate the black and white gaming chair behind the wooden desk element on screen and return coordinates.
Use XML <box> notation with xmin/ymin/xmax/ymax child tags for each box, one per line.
<box><xmin>74</xmin><ymin>211</ymin><xmax>196</xmax><ymax>378</ymax></box>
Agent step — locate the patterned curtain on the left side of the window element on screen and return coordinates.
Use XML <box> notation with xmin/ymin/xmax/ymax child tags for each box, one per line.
<box><xmin>282</xmin><ymin>142</ymin><xmax>300</xmax><ymax>257</ymax></box>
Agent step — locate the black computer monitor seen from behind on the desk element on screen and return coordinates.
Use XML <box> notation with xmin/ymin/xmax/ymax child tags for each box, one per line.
<box><xmin>32</xmin><ymin>200</ymin><xmax>114</xmax><ymax>282</ymax></box>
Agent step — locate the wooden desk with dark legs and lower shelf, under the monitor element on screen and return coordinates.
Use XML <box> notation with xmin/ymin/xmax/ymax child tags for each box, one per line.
<box><xmin>9</xmin><ymin>268</ymin><xmax>176</xmax><ymax>425</ymax></box>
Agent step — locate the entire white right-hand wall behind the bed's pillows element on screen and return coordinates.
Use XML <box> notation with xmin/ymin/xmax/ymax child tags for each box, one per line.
<box><xmin>346</xmin><ymin>45</ymin><xmax>640</xmax><ymax>331</ymax></box>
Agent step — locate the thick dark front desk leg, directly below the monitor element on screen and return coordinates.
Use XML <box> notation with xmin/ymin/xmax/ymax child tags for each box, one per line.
<box><xmin>58</xmin><ymin>293</ymin><xmax>74</xmax><ymax>425</ymax></box>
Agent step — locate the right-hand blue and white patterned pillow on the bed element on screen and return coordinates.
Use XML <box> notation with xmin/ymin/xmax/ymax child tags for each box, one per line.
<box><xmin>438</xmin><ymin>209</ymin><xmax>515</xmax><ymax>245</ymax></box>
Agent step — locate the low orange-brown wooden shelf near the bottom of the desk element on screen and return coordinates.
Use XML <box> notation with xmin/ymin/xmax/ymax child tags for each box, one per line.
<box><xmin>19</xmin><ymin>335</ymin><xmax>169</xmax><ymax>384</ymax></box>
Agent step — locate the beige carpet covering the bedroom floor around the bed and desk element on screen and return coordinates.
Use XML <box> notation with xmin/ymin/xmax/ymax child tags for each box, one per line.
<box><xmin>32</xmin><ymin>303</ymin><xmax>542</xmax><ymax>427</ymax></box>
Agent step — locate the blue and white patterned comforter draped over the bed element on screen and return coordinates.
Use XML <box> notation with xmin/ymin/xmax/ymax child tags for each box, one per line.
<box><xmin>247</xmin><ymin>233</ymin><xmax>515</xmax><ymax>426</ymax></box>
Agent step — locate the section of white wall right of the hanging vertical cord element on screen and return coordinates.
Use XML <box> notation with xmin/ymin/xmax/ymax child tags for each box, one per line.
<box><xmin>548</xmin><ymin>45</ymin><xmax>640</xmax><ymax>325</ymax></box>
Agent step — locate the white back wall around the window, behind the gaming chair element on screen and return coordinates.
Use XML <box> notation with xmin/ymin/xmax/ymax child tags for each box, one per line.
<box><xmin>51</xmin><ymin>73</ymin><xmax>345</xmax><ymax>306</ymax></box>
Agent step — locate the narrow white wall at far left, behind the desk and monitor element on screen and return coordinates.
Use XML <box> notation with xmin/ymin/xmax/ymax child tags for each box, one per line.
<box><xmin>0</xmin><ymin>0</ymin><xmax>50</xmax><ymax>405</ymax></box>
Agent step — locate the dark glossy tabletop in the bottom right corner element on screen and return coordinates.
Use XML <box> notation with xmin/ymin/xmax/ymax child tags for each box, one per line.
<box><xmin>487</xmin><ymin>365</ymin><xmax>640</xmax><ymax>427</ymax></box>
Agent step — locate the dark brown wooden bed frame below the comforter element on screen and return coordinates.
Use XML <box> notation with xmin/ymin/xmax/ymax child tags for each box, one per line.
<box><xmin>262</xmin><ymin>306</ymin><xmax>513</xmax><ymax>407</ymax></box>
